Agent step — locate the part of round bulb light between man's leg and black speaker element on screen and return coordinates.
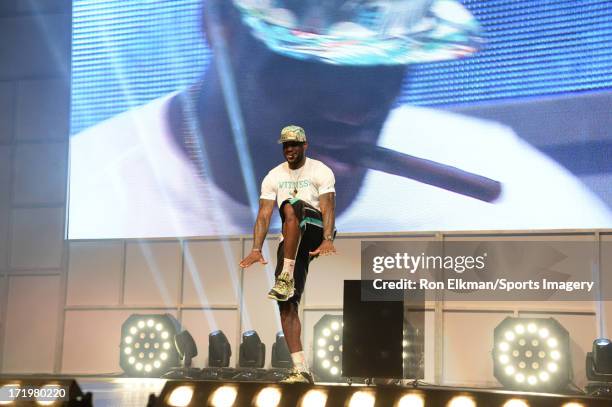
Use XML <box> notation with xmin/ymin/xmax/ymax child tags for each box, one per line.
<box><xmin>312</xmin><ymin>314</ymin><xmax>343</xmax><ymax>382</ymax></box>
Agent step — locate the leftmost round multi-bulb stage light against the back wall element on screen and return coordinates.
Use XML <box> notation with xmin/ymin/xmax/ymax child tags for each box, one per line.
<box><xmin>119</xmin><ymin>314</ymin><xmax>179</xmax><ymax>377</ymax></box>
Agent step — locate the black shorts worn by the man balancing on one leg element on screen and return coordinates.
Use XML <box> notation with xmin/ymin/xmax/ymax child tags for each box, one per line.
<box><xmin>274</xmin><ymin>199</ymin><xmax>323</xmax><ymax>305</ymax></box>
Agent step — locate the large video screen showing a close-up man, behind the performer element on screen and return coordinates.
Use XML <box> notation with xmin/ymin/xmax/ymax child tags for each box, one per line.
<box><xmin>67</xmin><ymin>0</ymin><xmax>612</xmax><ymax>239</ymax></box>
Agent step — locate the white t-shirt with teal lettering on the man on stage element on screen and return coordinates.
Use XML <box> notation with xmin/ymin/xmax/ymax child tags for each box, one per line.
<box><xmin>260</xmin><ymin>158</ymin><xmax>336</xmax><ymax>210</ymax></box>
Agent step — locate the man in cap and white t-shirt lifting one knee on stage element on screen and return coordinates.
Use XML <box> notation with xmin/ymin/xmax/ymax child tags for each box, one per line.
<box><xmin>240</xmin><ymin>126</ymin><xmax>336</xmax><ymax>384</ymax></box>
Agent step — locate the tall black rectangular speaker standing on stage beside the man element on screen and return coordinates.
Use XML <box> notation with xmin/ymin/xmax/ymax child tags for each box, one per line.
<box><xmin>342</xmin><ymin>280</ymin><xmax>404</xmax><ymax>379</ymax></box>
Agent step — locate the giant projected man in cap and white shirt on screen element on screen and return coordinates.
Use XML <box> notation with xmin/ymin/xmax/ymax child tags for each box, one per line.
<box><xmin>68</xmin><ymin>0</ymin><xmax>612</xmax><ymax>238</ymax></box>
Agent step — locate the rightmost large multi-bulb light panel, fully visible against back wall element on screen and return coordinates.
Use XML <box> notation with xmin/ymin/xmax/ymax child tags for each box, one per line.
<box><xmin>493</xmin><ymin>317</ymin><xmax>570</xmax><ymax>391</ymax></box>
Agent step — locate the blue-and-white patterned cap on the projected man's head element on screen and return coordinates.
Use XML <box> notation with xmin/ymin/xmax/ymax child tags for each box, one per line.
<box><xmin>234</xmin><ymin>0</ymin><xmax>482</xmax><ymax>66</ymax></box>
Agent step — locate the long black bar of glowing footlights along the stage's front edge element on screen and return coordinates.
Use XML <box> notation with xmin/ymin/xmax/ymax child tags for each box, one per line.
<box><xmin>147</xmin><ymin>380</ymin><xmax>610</xmax><ymax>407</ymax></box>
